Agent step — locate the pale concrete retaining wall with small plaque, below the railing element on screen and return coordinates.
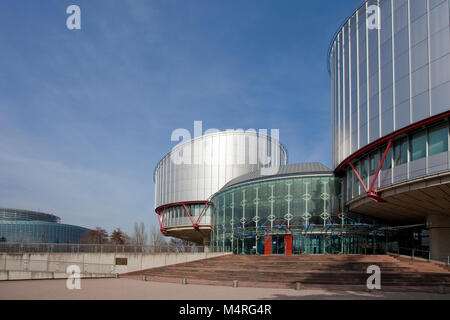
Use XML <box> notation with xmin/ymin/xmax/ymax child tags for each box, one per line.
<box><xmin>0</xmin><ymin>252</ymin><xmax>228</xmax><ymax>280</ymax></box>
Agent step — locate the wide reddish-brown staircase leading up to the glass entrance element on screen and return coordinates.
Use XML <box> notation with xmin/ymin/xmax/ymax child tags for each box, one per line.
<box><xmin>124</xmin><ymin>255</ymin><xmax>450</xmax><ymax>292</ymax></box>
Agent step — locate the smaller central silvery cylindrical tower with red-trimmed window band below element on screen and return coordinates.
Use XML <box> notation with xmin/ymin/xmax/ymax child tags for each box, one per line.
<box><xmin>154</xmin><ymin>130</ymin><xmax>287</xmax><ymax>243</ymax></box>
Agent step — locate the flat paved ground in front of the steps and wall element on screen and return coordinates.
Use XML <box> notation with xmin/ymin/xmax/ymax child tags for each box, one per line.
<box><xmin>0</xmin><ymin>278</ymin><xmax>450</xmax><ymax>300</ymax></box>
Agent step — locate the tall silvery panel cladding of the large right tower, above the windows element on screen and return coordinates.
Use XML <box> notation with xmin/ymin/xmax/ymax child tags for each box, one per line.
<box><xmin>328</xmin><ymin>0</ymin><xmax>450</xmax><ymax>168</ymax></box>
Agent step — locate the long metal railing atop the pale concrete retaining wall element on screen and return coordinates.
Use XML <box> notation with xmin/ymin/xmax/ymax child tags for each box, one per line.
<box><xmin>0</xmin><ymin>242</ymin><xmax>231</xmax><ymax>254</ymax></box>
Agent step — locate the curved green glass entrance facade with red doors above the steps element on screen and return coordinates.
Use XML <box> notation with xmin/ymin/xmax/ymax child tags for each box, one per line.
<box><xmin>211</xmin><ymin>174</ymin><xmax>385</xmax><ymax>254</ymax></box>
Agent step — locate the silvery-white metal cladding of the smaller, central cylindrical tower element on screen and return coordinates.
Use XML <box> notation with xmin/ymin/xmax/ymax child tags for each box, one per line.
<box><xmin>154</xmin><ymin>131</ymin><xmax>287</xmax><ymax>208</ymax></box>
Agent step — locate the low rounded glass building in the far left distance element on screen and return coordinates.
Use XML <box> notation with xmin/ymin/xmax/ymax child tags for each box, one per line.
<box><xmin>0</xmin><ymin>208</ymin><xmax>88</xmax><ymax>243</ymax></box>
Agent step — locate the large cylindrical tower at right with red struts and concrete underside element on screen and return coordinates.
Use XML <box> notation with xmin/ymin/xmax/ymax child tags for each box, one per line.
<box><xmin>328</xmin><ymin>0</ymin><xmax>450</xmax><ymax>258</ymax></box>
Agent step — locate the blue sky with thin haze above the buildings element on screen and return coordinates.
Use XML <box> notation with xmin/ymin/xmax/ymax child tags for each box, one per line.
<box><xmin>0</xmin><ymin>0</ymin><xmax>360</xmax><ymax>232</ymax></box>
